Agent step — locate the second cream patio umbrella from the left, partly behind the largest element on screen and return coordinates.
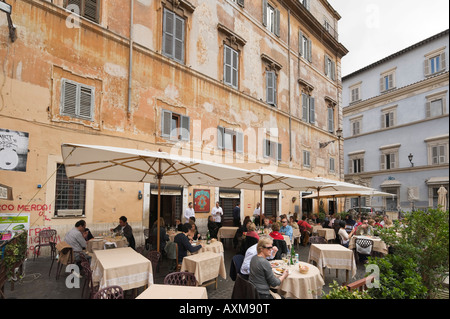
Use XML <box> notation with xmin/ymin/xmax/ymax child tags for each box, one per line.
<box><xmin>208</xmin><ymin>169</ymin><xmax>329</xmax><ymax>223</ymax></box>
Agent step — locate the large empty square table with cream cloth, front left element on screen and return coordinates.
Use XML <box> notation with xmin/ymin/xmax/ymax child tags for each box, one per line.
<box><xmin>91</xmin><ymin>247</ymin><xmax>153</xmax><ymax>290</ymax></box>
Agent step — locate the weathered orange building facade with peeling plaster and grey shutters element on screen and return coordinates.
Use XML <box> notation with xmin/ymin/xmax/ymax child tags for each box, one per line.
<box><xmin>0</xmin><ymin>0</ymin><xmax>347</xmax><ymax>255</ymax></box>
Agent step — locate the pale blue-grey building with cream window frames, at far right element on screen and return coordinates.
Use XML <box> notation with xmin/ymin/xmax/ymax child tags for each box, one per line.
<box><xmin>343</xmin><ymin>30</ymin><xmax>449</xmax><ymax>217</ymax></box>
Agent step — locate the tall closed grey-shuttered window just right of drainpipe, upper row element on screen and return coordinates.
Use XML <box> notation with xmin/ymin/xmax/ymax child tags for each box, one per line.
<box><xmin>162</xmin><ymin>9</ymin><xmax>185</xmax><ymax>63</ymax></box>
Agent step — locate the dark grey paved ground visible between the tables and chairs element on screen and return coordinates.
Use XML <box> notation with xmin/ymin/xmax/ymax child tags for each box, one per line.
<box><xmin>5</xmin><ymin>240</ymin><xmax>364</xmax><ymax>299</ymax></box>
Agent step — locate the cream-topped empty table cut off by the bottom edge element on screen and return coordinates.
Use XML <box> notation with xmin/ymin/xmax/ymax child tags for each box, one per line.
<box><xmin>136</xmin><ymin>285</ymin><xmax>208</xmax><ymax>299</ymax></box>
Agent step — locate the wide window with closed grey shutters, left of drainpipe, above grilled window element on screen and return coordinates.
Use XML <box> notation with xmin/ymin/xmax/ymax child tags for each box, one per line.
<box><xmin>60</xmin><ymin>79</ymin><xmax>95</xmax><ymax>121</ymax></box>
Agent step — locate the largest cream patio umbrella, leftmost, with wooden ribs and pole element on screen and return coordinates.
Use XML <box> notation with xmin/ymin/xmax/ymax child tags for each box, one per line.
<box><xmin>61</xmin><ymin>144</ymin><xmax>248</xmax><ymax>251</ymax></box>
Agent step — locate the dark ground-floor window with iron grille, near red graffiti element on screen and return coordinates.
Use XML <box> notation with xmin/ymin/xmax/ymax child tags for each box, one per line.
<box><xmin>55</xmin><ymin>164</ymin><xmax>86</xmax><ymax>215</ymax></box>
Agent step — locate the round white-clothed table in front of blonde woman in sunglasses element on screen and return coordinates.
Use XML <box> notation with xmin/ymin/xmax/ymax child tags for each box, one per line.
<box><xmin>271</xmin><ymin>260</ymin><xmax>325</xmax><ymax>299</ymax></box>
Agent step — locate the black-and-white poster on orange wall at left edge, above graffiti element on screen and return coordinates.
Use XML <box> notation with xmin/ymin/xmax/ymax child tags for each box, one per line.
<box><xmin>0</xmin><ymin>128</ymin><xmax>29</xmax><ymax>172</ymax></box>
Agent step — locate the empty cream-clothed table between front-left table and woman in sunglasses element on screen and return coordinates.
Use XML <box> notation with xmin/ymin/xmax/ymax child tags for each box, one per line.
<box><xmin>181</xmin><ymin>251</ymin><xmax>227</xmax><ymax>288</ymax></box>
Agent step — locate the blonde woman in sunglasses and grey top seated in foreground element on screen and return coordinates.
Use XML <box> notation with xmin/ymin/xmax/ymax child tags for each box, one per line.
<box><xmin>249</xmin><ymin>237</ymin><xmax>289</xmax><ymax>299</ymax></box>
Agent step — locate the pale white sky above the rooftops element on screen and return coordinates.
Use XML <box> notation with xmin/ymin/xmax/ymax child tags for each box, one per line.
<box><xmin>328</xmin><ymin>0</ymin><xmax>449</xmax><ymax>76</ymax></box>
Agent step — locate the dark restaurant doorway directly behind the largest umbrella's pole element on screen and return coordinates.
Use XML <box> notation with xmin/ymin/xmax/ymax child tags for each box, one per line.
<box><xmin>149</xmin><ymin>185</ymin><xmax>183</xmax><ymax>229</ymax></box>
